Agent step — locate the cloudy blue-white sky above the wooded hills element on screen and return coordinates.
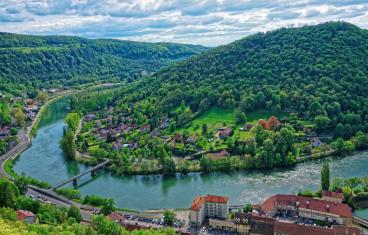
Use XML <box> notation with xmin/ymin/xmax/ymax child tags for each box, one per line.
<box><xmin>0</xmin><ymin>0</ymin><xmax>368</xmax><ymax>46</ymax></box>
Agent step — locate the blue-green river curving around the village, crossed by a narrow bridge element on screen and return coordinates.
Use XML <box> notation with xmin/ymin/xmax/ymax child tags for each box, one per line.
<box><xmin>14</xmin><ymin>98</ymin><xmax>368</xmax><ymax>213</ymax></box>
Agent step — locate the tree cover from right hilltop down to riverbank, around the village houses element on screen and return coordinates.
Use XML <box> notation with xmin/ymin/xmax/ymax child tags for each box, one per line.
<box><xmin>69</xmin><ymin>22</ymin><xmax>368</xmax><ymax>174</ymax></box>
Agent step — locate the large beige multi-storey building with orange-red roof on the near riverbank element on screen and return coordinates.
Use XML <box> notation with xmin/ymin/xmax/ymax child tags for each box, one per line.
<box><xmin>189</xmin><ymin>195</ymin><xmax>229</xmax><ymax>226</ymax></box>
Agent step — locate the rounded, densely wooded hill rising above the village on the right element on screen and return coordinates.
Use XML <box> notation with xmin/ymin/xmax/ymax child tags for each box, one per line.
<box><xmin>125</xmin><ymin>22</ymin><xmax>368</xmax><ymax>132</ymax></box>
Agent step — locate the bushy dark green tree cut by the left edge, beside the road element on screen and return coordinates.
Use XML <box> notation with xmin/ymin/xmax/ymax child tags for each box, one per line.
<box><xmin>0</xmin><ymin>180</ymin><xmax>19</xmax><ymax>208</ymax></box>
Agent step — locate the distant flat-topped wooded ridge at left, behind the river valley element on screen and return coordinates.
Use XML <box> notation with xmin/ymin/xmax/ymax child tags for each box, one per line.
<box><xmin>0</xmin><ymin>33</ymin><xmax>207</xmax><ymax>93</ymax></box>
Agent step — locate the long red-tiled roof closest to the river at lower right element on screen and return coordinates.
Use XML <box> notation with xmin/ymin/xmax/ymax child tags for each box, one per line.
<box><xmin>261</xmin><ymin>194</ymin><xmax>353</xmax><ymax>218</ymax></box>
